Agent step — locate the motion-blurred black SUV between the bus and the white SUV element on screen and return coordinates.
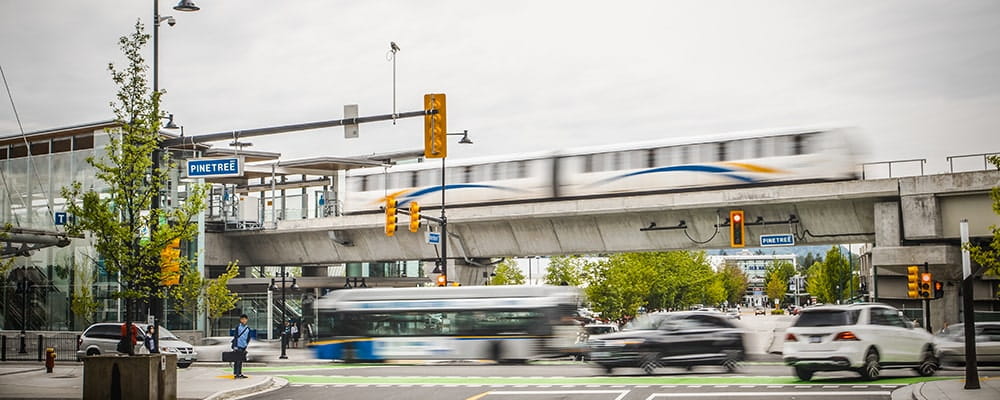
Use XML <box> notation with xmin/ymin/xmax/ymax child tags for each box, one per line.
<box><xmin>589</xmin><ymin>311</ymin><xmax>746</xmax><ymax>374</ymax></box>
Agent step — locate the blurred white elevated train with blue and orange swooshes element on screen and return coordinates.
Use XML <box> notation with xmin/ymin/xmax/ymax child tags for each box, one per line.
<box><xmin>344</xmin><ymin>128</ymin><xmax>860</xmax><ymax>214</ymax></box>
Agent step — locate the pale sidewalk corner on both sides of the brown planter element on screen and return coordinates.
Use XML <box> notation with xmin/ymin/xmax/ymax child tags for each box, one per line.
<box><xmin>0</xmin><ymin>363</ymin><xmax>286</xmax><ymax>400</ymax></box>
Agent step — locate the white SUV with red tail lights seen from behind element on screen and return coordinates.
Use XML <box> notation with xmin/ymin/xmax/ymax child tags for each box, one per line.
<box><xmin>782</xmin><ymin>303</ymin><xmax>938</xmax><ymax>381</ymax></box>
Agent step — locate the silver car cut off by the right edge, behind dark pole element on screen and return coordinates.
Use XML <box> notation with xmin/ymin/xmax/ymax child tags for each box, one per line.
<box><xmin>934</xmin><ymin>322</ymin><xmax>1000</xmax><ymax>365</ymax></box>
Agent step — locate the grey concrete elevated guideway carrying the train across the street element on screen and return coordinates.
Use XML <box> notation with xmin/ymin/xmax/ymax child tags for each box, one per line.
<box><xmin>206</xmin><ymin>171</ymin><xmax>1000</xmax><ymax>265</ymax></box>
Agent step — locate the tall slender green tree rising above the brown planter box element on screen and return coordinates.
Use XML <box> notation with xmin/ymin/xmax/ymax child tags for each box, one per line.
<box><xmin>62</xmin><ymin>22</ymin><xmax>206</xmax><ymax>354</ymax></box>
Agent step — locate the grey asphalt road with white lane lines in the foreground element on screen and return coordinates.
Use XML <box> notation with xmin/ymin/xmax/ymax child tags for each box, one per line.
<box><xmin>240</xmin><ymin>362</ymin><xmax>984</xmax><ymax>400</ymax></box>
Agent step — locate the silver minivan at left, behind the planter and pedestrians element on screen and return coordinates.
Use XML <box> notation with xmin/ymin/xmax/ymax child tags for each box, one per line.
<box><xmin>76</xmin><ymin>322</ymin><xmax>198</xmax><ymax>368</ymax></box>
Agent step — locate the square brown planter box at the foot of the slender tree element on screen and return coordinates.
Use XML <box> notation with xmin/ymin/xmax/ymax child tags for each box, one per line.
<box><xmin>83</xmin><ymin>354</ymin><xmax>177</xmax><ymax>400</ymax></box>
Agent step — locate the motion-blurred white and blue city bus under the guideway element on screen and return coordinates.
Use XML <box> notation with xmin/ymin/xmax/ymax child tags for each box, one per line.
<box><xmin>311</xmin><ymin>286</ymin><xmax>583</xmax><ymax>362</ymax></box>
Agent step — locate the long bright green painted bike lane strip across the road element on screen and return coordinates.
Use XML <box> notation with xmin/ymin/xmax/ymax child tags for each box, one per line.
<box><xmin>281</xmin><ymin>375</ymin><xmax>955</xmax><ymax>385</ymax></box>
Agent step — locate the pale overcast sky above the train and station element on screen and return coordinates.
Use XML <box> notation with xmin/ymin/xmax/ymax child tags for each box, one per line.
<box><xmin>0</xmin><ymin>0</ymin><xmax>1000</xmax><ymax>170</ymax></box>
